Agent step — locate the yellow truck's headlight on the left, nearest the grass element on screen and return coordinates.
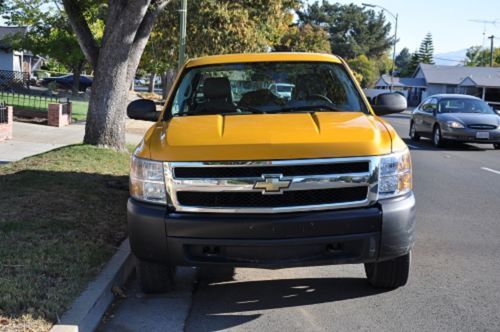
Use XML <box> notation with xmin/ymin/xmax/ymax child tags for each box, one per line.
<box><xmin>130</xmin><ymin>156</ymin><xmax>167</xmax><ymax>205</ymax></box>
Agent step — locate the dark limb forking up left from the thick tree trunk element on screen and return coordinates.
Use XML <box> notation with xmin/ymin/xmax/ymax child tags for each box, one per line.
<box><xmin>62</xmin><ymin>0</ymin><xmax>99</xmax><ymax>70</ymax></box>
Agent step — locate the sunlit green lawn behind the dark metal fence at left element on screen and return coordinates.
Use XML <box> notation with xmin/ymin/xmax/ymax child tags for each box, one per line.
<box><xmin>0</xmin><ymin>93</ymin><xmax>89</xmax><ymax>121</ymax></box>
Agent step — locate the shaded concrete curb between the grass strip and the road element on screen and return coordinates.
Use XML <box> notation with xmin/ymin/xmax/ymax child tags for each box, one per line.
<box><xmin>50</xmin><ymin>238</ymin><xmax>134</xmax><ymax>332</ymax></box>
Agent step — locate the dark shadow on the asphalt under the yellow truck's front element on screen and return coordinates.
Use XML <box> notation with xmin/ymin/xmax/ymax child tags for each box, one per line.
<box><xmin>187</xmin><ymin>278</ymin><xmax>386</xmax><ymax>331</ymax></box>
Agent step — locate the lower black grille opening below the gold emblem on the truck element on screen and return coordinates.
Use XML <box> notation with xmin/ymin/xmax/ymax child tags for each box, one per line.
<box><xmin>177</xmin><ymin>186</ymin><xmax>368</xmax><ymax>208</ymax></box>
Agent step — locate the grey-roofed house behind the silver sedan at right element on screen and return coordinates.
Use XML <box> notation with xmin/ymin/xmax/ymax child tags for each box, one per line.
<box><xmin>376</xmin><ymin>63</ymin><xmax>500</xmax><ymax>108</ymax></box>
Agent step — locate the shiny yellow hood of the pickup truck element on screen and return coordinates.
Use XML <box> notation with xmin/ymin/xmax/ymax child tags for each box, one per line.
<box><xmin>143</xmin><ymin>112</ymin><xmax>391</xmax><ymax>161</ymax></box>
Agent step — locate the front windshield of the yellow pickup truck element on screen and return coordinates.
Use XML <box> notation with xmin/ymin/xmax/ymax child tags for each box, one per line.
<box><xmin>171</xmin><ymin>62</ymin><xmax>368</xmax><ymax>116</ymax></box>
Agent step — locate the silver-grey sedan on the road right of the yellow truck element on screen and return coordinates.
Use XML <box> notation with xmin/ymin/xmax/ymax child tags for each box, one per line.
<box><xmin>410</xmin><ymin>94</ymin><xmax>500</xmax><ymax>149</ymax></box>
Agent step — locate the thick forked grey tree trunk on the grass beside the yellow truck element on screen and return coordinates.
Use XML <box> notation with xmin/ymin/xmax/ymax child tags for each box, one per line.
<box><xmin>62</xmin><ymin>0</ymin><xmax>170</xmax><ymax>150</ymax></box>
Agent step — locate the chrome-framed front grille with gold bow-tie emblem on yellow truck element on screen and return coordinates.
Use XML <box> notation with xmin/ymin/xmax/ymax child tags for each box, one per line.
<box><xmin>165</xmin><ymin>157</ymin><xmax>379</xmax><ymax>213</ymax></box>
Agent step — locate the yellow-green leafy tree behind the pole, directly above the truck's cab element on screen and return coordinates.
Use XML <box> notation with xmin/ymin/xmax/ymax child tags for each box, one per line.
<box><xmin>140</xmin><ymin>0</ymin><xmax>299</xmax><ymax>95</ymax></box>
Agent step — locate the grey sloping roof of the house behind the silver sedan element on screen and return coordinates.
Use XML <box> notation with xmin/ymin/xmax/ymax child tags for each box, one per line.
<box><xmin>417</xmin><ymin>63</ymin><xmax>500</xmax><ymax>87</ymax></box>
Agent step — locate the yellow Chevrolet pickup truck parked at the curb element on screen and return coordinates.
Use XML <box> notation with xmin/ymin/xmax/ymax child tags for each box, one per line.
<box><xmin>127</xmin><ymin>53</ymin><xmax>415</xmax><ymax>292</ymax></box>
